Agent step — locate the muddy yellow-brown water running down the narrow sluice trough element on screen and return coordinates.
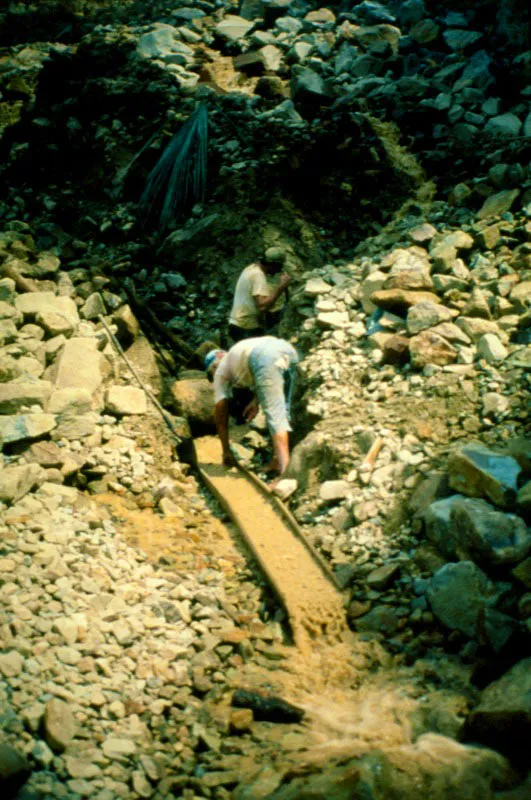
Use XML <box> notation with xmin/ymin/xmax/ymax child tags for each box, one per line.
<box><xmin>196</xmin><ymin>437</ymin><xmax>346</xmax><ymax>647</ymax></box>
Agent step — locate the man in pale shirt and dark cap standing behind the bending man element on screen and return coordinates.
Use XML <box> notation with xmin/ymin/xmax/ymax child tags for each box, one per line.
<box><xmin>229</xmin><ymin>247</ymin><xmax>291</xmax><ymax>342</ymax></box>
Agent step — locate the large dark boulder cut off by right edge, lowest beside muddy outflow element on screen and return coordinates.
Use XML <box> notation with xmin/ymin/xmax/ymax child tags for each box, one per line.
<box><xmin>464</xmin><ymin>658</ymin><xmax>531</xmax><ymax>765</ymax></box>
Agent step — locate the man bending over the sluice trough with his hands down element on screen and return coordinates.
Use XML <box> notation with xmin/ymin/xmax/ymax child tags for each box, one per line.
<box><xmin>205</xmin><ymin>336</ymin><xmax>299</xmax><ymax>475</ymax></box>
